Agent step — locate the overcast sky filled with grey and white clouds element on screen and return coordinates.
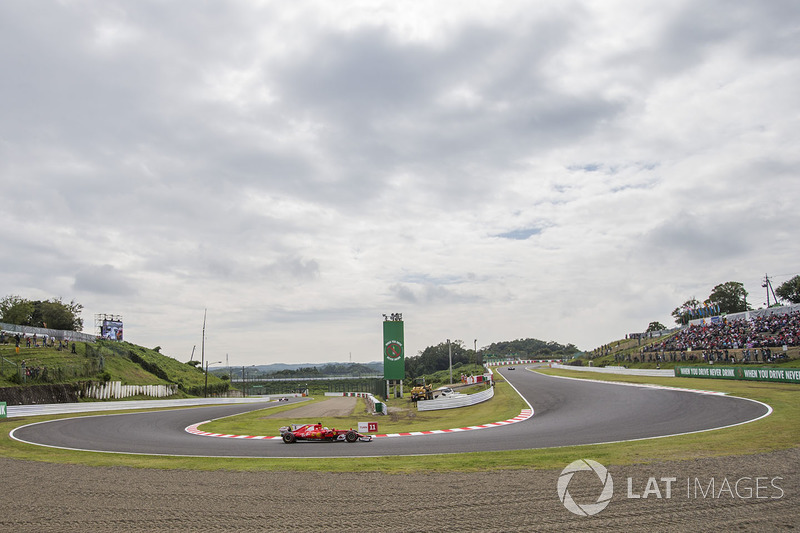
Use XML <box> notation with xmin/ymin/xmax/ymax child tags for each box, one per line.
<box><xmin>0</xmin><ymin>0</ymin><xmax>800</xmax><ymax>365</ymax></box>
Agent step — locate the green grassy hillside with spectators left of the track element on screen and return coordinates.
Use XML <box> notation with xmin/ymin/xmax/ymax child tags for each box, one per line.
<box><xmin>0</xmin><ymin>340</ymin><xmax>228</xmax><ymax>395</ymax></box>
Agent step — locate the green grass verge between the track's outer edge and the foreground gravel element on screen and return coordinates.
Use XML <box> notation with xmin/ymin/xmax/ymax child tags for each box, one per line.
<box><xmin>0</xmin><ymin>370</ymin><xmax>800</xmax><ymax>473</ymax></box>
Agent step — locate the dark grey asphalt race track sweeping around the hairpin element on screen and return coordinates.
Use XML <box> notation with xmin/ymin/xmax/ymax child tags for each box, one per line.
<box><xmin>12</xmin><ymin>367</ymin><xmax>770</xmax><ymax>457</ymax></box>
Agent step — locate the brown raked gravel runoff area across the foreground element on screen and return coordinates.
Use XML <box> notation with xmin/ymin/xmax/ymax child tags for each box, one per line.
<box><xmin>0</xmin><ymin>448</ymin><xmax>800</xmax><ymax>532</ymax></box>
